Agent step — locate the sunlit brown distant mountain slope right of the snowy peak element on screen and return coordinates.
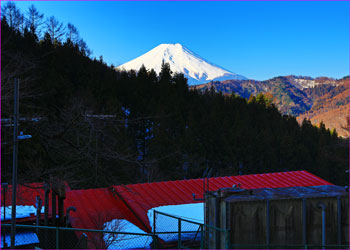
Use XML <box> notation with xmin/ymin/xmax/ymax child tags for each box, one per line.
<box><xmin>191</xmin><ymin>75</ymin><xmax>349</xmax><ymax>136</ymax></box>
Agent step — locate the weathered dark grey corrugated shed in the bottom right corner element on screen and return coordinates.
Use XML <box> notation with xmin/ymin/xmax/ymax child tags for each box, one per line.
<box><xmin>206</xmin><ymin>185</ymin><xmax>349</xmax><ymax>248</ymax></box>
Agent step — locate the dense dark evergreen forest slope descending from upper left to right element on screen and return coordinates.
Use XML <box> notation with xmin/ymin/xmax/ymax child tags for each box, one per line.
<box><xmin>1</xmin><ymin>2</ymin><xmax>348</xmax><ymax>188</ymax></box>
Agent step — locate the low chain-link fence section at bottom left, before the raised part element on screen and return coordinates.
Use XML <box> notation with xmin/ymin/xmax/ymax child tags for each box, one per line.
<box><xmin>1</xmin><ymin>224</ymin><xmax>158</xmax><ymax>249</ymax></box>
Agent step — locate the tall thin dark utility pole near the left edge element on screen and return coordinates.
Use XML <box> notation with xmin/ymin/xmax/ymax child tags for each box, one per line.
<box><xmin>11</xmin><ymin>78</ymin><xmax>19</xmax><ymax>248</ymax></box>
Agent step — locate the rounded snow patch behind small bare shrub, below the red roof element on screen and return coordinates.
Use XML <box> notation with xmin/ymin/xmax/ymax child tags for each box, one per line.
<box><xmin>103</xmin><ymin>219</ymin><xmax>152</xmax><ymax>249</ymax></box>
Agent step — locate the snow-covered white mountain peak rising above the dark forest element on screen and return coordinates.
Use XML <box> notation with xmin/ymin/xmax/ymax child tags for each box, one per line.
<box><xmin>117</xmin><ymin>43</ymin><xmax>247</xmax><ymax>85</ymax></box>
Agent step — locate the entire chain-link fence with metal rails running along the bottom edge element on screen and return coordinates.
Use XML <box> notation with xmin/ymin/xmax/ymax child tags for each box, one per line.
<box><xmin>4</xmin><ymin>223</ymin><xmax>349</xmax><ymax>249</ymax></box>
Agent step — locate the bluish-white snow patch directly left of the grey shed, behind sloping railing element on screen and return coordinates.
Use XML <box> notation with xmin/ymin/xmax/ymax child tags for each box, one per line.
<box><xmin>147</xmin><ymin>203</ymin><xmax>204</xmax><ymax>242</ymax></box>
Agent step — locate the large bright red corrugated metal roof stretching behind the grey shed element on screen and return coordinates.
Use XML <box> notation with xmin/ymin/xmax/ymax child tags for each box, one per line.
<box><xmin>113</xmin><ymin>171</ymin><xmax>333</xmax><ymax>231</ymax></box>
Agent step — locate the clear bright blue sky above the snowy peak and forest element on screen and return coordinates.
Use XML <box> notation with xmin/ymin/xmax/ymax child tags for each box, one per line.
<box><xmin>9</xmin><ymin>1</ymin><xmax>349</xmax><ymax>80</ymax></box>
